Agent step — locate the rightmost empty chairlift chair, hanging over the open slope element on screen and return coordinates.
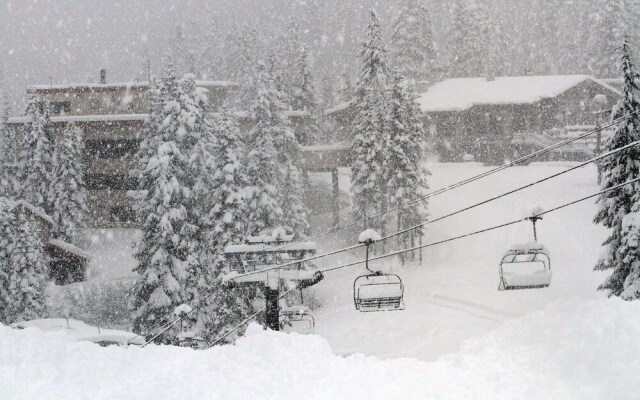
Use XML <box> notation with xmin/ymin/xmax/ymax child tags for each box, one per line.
<box><xmin>498</xmin><ymin>216</ymin><xmax>551</xmax><ymax>290</ymax></box>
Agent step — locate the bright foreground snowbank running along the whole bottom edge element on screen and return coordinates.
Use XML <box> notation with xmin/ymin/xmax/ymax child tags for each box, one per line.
<box><xmin>0</xmin><ymin>299</ymin><xmax>640</xmax><ymax>400</ymax></box>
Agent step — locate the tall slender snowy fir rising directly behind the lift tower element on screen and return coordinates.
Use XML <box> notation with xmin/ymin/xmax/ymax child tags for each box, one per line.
<box><xmin>246</xmin><ymin>63</ymin><xmax>284</xmax><ymax>234</ymax></box>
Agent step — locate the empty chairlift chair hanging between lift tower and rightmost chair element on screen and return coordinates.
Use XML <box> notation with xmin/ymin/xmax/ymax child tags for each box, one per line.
<box><xmin>353</xmin><ymin>232</ymin><xmax>404</xmax><ymax>312</ymax></box>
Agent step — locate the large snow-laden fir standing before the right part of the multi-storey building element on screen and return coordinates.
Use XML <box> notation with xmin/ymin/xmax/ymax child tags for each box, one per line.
<box><xmin>133</xmin><ymin>58</ymin><xmax>199</xmax><ymax>342</ymax></box>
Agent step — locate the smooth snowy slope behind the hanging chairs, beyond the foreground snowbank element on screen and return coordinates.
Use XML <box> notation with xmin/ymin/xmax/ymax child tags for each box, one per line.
<box><xmin>314</xmin><ymin>163</ymin><xmax>606</xmax><ymax>360</ymax></box>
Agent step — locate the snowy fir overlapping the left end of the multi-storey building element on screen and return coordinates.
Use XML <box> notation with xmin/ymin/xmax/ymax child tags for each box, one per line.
<box><xmin>18</xmin><ymin>91</ymin><xmax>54</xmax><ymax>213</ymax></box>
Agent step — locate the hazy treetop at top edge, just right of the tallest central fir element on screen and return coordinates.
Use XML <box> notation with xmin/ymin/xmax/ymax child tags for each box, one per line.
<box><xmin>390</xmin><ymin>0</ymin><xmax>439</xmax><ymax>80</ymax></box>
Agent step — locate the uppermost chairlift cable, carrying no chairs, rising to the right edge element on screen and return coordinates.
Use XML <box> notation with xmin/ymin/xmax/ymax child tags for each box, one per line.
<box><xmin>268</xmin><ymin>111</ymin><xmax>640</xmax><ymax>249</ymax></box>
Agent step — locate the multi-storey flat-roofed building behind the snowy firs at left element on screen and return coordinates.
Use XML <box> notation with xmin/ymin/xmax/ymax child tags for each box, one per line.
<box><xmin>9</xmin><ymin>71</ymin><xmax>314</xmax><ymax>228</ymax></box>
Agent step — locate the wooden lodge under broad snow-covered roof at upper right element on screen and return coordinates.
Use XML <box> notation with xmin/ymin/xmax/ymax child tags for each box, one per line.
<box><xmin>327</xmin><ymin>75</ymin><xmax>621</xmax><ymax>163</ymax></box>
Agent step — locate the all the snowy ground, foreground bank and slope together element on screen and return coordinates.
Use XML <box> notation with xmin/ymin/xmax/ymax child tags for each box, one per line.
<box><xmin>0</xmin><ymin>163</ymin><xmax>640</xmax><ymax>399</ymax></box>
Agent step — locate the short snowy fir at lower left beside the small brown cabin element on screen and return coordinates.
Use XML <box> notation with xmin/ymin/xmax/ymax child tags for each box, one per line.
<box><xmin>7</xmin><ymin>213</ymin><xmax>48</xmax><ymax>323</ymax></box>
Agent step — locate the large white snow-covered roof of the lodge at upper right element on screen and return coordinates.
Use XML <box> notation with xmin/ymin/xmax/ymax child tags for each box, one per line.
<box><xmin>418</xmin><ymin>75</ymin><xmax>620</xmax><ymax>112</ymax></box>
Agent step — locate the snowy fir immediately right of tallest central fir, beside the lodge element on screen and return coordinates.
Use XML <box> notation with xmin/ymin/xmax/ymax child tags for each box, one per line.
<box><xmin>385</xmin><ymin>75</ymin><xmax>429</xmax><ymax>260</ymax></box>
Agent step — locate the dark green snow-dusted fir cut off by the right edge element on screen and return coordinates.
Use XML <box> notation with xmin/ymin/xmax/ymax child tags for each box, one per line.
<box><xmin>594</xmin><ymin>39</ymin><xmax>640</xmax><ymax>298</ymax></box>
